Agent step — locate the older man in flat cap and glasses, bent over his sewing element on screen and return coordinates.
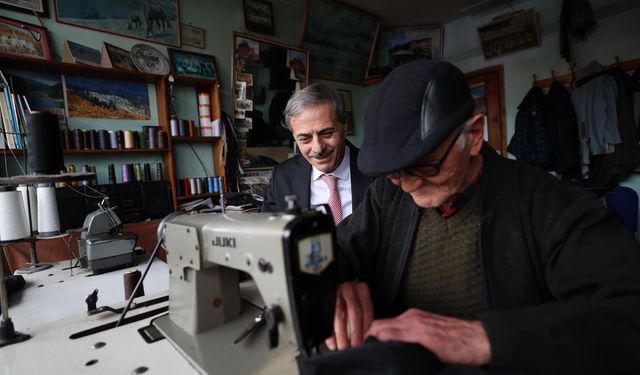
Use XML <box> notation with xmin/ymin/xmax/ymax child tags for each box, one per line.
<box><xmin>327</xmin><ymin>61</ymin><xmax>640</xmax><ymax>374</ymax></box>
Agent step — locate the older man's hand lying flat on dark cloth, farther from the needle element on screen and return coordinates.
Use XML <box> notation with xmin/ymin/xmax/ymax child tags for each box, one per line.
<box><xmin>366</xmin><ymin>309</ymin><xmax>491</xmax><ymax>366</ymax></box>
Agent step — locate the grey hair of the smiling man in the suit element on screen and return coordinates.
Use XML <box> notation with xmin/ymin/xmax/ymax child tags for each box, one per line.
<box><xmin>284</xmin><ymin>83</ymin><xmax>353</xmax><ymax>129</ymax></box>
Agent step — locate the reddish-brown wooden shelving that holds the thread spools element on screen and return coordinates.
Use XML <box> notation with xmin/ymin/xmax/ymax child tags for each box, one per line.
<box><xmin>0</xmin><ymin>53</ymin><xmax>226</xmax><ymax>209</ymax></box>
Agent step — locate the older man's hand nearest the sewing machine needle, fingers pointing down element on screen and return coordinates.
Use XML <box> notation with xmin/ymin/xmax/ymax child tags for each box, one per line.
<box><xmin>325</xmin><ymin>281</ymin><xmax>373</xmax><ymax>350</ymax></box>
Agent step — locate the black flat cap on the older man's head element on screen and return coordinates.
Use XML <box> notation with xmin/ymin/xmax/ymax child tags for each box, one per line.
<box><xmin>358</xmin><ymin>60</ymin><xmax>475</xmax><ymax>176</ymax></box>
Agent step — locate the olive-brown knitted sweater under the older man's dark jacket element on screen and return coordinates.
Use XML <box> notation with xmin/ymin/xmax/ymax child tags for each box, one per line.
<box><xmin>402</xmin><ymin>188</ymin><xmax>484</xmax><ymax>319</ymax></box>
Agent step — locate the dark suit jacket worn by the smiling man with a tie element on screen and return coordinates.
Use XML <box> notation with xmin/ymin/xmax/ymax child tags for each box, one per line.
<box><xmin>262</xmin><ymin>141</ymin><xmax>374</xmax><ymax>212</ymax></box>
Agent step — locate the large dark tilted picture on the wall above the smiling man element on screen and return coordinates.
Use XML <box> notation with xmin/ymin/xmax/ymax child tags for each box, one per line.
<box><xmin>301</xmin><ymin>0</ymin><xmax>380</xmax><ymax>84</ymax></box>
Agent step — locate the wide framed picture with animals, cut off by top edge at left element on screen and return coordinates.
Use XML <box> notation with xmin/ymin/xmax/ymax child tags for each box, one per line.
<box><xmin>55</xmin><ymin>0</ymin><xmax>180</xmax><ymax>47</ymax></box>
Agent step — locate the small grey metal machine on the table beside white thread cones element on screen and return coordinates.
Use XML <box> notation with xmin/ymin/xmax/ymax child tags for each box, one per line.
<box><xmin>78</xmin><ymin>198</ymin><xmax>137</xmax><ymax>273</ymax></box>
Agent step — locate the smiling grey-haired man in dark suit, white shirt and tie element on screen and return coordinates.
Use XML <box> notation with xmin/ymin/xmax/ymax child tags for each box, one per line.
<box><xmin>262</xmin><ymin>83</ymin><xmax>373</xmax><ymax>224</ymax></box>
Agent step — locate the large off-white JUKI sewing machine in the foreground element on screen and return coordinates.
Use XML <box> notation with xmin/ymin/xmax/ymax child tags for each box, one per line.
<box><xmin>153</xmin><ymin>207</ymin><xmax>336</xmax><ymax>374</ymax></box>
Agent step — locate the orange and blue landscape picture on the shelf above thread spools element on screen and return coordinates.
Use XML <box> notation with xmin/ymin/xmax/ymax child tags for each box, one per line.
<box><xmin>65</xmin><ymin>76</ymin><xmax>151</xmax><ymax>120</ymax></box>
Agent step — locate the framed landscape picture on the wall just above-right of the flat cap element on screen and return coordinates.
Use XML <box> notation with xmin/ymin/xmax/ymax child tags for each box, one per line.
<box><xmin>367</xmin><ymin>25</ymin><xmax>443</xmax><ymax>78</ymax></box>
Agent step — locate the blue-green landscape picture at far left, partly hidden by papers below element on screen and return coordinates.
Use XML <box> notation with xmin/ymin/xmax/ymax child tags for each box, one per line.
<box><xmin>6</xmin><ymin>70</ymin><xmax>66</xmax><ymax>125</ymax></box>
